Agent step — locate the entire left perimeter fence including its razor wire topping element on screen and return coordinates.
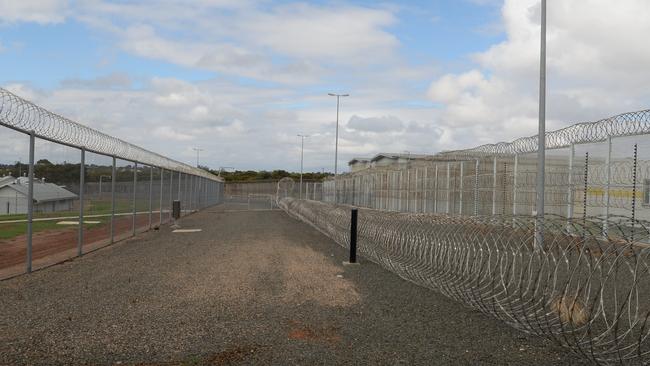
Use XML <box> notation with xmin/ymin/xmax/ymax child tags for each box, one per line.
<box><xmin>0</xmin><ymin>88</ymin><xmax>223</xmax><ymax>278</ymax></box>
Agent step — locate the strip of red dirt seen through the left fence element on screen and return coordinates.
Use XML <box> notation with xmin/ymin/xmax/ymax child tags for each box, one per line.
<box><xmin>0</xmin><ymin>214</ymin><xmax>164</xmax><ymax>278</ymax></box>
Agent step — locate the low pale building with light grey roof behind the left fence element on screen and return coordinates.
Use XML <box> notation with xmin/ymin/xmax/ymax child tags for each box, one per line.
<box><xmin>0</xmin><ymin>176</ymin><xmax>77</xmax><ymax>215</ymax></box>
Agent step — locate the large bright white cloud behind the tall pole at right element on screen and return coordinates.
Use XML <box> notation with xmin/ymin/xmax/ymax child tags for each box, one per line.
<box><xmin>428</xmin><ymin>0</ymin><xmax>650</xmax><ymax>148</ymax></box>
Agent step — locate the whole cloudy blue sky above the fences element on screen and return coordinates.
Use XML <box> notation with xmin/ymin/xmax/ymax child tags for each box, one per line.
<box><xmin>0</xmin><ymin>0</ymin><xmax>650</xmax><ymax>171</ymax></box>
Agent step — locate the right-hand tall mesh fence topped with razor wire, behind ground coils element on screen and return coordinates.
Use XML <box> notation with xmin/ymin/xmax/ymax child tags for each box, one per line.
<box><xmin>324</xmin><ymin>111</ymin><xmax>650</xmax><ymax>232</ymax></box>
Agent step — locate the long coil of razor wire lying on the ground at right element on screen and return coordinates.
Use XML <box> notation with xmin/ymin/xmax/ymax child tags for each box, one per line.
<box><xmin>280</xmin><ymin>198</ymin><xmax>650</xmax><ymax>364</ymax></box>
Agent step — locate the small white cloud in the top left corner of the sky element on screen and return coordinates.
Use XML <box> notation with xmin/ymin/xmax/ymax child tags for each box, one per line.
<box><xmin>0</xmin><ymin>0</ymin><xmax>69</xmax><ymax>24</ymax></box>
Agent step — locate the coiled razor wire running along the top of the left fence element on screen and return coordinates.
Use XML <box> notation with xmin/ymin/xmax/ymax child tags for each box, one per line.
<box><xmin>0</xmin><ymin>88</ymin><xmax>218</xmax><ymax>180</ymax></box>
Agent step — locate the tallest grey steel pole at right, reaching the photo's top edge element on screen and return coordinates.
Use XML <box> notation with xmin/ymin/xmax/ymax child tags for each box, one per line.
<box><xmin>535</xmin><ymin>0</ymin><xmax>546</xmax><ymax>249</ymax></box>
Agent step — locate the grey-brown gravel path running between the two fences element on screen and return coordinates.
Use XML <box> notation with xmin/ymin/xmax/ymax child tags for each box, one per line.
<box><xmin>0</xmin><ymin>206</ymin><xmax>580</xmax><ymax>365</ymax></box>
